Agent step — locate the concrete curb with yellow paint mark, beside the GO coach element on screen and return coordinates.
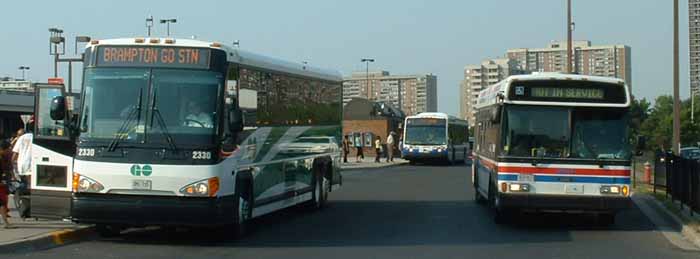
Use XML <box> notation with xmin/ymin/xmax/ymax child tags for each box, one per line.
<box><xmin>0</xmin><ymin>226</ymin><xmax>95</xmax><ymax>254</ymax></box>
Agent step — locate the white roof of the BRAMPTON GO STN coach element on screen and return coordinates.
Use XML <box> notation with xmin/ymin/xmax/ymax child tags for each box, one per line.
<box><xmin>85</xmin><ymin>38</ymin><xmax>343</xmax><ymax>82</ymax></box>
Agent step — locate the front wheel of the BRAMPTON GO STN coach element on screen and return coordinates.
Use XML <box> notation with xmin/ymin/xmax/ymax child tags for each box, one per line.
<box><xmin>234</xmin><ymin>181</ymin><xmax>253</xmax><ymax>238</ymax></box>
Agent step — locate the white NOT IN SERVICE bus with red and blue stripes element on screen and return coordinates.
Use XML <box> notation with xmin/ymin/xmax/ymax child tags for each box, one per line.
<box><xmin>472</xmin><ymin>74</ymin><xmax>632</xmax><ymax>225</ymax></box>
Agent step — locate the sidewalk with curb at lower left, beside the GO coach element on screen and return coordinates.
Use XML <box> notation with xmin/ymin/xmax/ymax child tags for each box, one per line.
<box><xmin>0</xmin><ymin>196</ymin><xmax>91</xmax><ymax>254</ymax></box>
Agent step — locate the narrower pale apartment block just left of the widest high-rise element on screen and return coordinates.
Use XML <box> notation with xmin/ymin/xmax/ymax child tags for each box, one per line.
<box><xmin>459</xmin><ymin>58</ymin><xmax>519</xmax><ymax>126</ymax></box>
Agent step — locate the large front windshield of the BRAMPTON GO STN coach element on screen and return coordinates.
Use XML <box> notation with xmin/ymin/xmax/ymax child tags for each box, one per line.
<box><xmin>81</xmin><ymin>68</ymin><xmax>223</xmax><ymax>145</ymax></box>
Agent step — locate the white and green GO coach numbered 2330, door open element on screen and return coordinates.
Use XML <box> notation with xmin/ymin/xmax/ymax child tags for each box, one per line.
<box><xmin>32</xmin><ymin>38</ymin><xmax>342</xmax><ymax>239</ymax></box>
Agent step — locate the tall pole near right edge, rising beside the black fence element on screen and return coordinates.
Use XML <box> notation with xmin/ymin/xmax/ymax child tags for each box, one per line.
<box><xmin>671</xmin><ymin>0</ymin><xmax>681</xmax><ymax>155</ymax></box>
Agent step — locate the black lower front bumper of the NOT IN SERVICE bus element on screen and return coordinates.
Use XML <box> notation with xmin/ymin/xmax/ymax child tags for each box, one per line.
<box><xmin>499</xmin><ymin>193</ymin><xmax>632</xmax><ymax>212</ymax></box>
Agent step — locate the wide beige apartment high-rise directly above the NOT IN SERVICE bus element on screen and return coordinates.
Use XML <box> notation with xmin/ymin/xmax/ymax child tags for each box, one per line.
<box><xmin>507</xmin><ymin>41</ymin><xmax>632</xmax><ymax>88</ymax></box>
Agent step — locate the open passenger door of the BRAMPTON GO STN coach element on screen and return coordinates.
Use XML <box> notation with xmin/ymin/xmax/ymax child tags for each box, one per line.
<box><xmin>30</xmin><ymin>84</ymin><xmax>77</xmax><ymax>219</ymax></box>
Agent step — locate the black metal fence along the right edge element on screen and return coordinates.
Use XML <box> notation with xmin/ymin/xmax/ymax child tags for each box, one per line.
<box><xmin>653</xmin><ymin>153</ymin><xmax>700</xmax><ymax>215</ymax></box>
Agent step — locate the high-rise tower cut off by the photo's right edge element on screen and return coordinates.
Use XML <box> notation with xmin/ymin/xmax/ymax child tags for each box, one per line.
<box><xmin>688</xmin><ymin>0</ymin><xmax>700</xmax><ymax>94</ymax></box>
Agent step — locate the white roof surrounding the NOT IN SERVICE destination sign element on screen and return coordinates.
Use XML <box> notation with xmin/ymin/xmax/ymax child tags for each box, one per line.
<box><xmin>475</xmin><ymin>72</ymin><xmax>631</xmax><ymax>109</ymax></box>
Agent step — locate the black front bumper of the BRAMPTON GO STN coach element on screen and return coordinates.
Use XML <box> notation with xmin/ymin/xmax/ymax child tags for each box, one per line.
<box><xmin>71</xmin><ymin>193</ymin><xmax>234</xmax><ymax>226</ymax></box>
